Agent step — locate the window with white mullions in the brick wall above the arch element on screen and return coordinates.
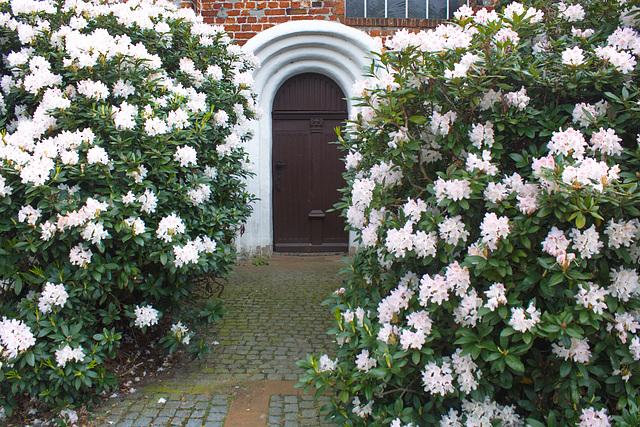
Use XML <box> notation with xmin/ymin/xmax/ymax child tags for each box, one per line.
<box><xmin>345</xmin><ymin>0</ymin><xmax>469</xmax><ymax>19</ymax></box>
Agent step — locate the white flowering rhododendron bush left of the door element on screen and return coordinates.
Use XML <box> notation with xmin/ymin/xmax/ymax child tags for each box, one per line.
<box><xmin>0</xmin><ymin>0</ymin><xmax>258</xmax><ymax>413</ymax></box>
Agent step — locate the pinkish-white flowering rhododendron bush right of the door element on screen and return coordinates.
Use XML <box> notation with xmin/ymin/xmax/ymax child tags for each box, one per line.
<box><xmin>300</xmin><ymin>1</ymin><xmax>640</xmax><ymax>427</ymax></box>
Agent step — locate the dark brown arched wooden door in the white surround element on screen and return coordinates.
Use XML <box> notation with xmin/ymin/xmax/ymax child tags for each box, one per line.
<box><xmin>272</xmin><ymin>73</ymin><xmax>349</xmax><ymax>252</ymax></box>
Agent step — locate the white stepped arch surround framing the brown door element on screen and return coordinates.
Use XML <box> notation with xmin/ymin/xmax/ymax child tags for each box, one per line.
<box><xmin>236</xmin><ymin>20</ymin><xmax>378</xmax><ymax>254</ymax></box>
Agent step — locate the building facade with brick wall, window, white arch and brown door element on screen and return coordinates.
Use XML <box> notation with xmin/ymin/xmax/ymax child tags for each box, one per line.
<box><xmin>180</xmin><ymin>0</ymin><xmax>475</xmax><ymax>254</ymax></box>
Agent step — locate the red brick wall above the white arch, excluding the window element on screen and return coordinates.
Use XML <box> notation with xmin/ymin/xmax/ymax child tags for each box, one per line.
<box><xmin>182</xmin><ymin>0</ymin><xmax>475</xmax><ymax>44</ymax></box>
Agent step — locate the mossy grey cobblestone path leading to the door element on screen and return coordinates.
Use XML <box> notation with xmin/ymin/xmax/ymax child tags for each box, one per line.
<box><xmin>91</xmin><ymin>255</ymin><xmax>345</xmax><ymax>427</ymax></box>
